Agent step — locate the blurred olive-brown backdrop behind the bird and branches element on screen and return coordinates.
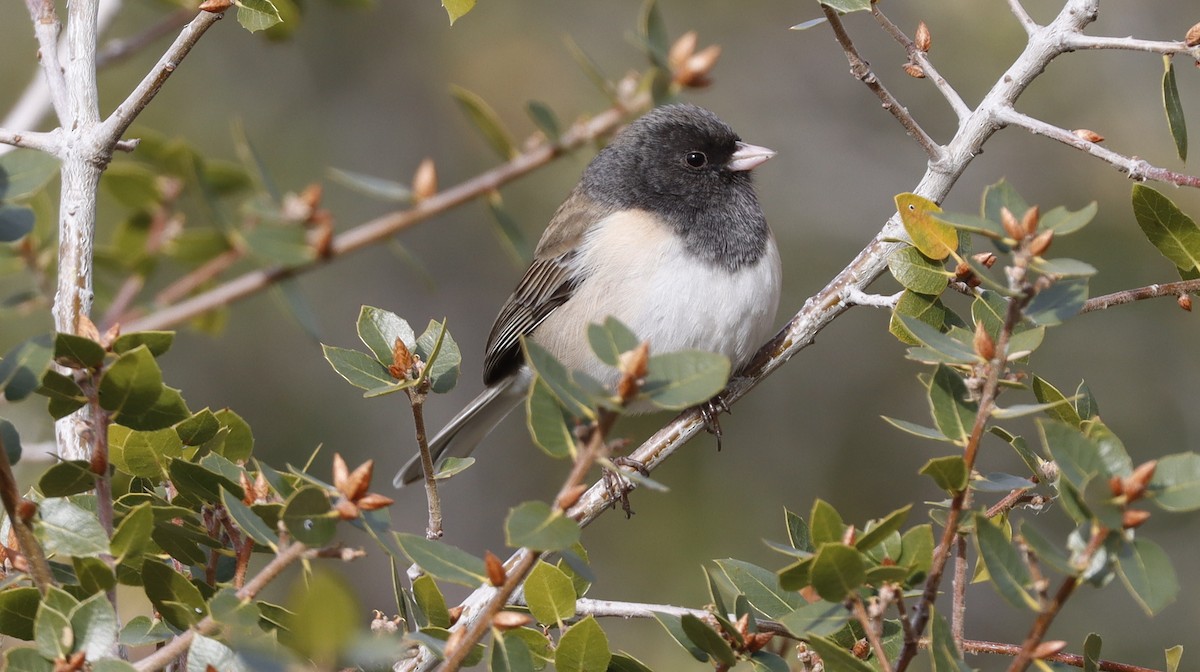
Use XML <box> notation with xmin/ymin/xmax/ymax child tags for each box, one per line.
<box><xmin>0</xmin><ymin>0</ymin><xmax>1200</xmax><ymax>670</ymax></box>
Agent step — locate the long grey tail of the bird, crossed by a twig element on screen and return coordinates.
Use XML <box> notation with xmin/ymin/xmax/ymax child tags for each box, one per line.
<box><xmin>391</xmin><ymin>374</ymin><xmax>528</xmax><ymax>487</ymax></box>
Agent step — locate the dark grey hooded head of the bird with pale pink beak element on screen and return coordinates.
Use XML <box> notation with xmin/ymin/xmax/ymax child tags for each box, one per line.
<box><xmin>580</xmin><ymin>104</ymin><xmax>774</xmax><ymax>270</ymax></box>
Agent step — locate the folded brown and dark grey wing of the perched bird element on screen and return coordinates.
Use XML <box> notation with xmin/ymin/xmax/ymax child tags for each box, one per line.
<box><xmin>484</xmin><ymin>191</ymin><xmax>611</xmax><ymax>385</ymax></box>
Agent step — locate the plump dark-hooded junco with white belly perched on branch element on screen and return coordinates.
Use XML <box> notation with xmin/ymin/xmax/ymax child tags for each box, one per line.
<box><xmin>395</xmin><ymin>104</ymin><xmax>780</xmax><ymax>487</ymax></box>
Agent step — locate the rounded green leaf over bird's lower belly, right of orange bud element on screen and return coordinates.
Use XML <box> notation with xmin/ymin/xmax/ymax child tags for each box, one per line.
<box><xmin>642</xmin><ymin>350</ymin><xmax>730</xmax><ymax>410</ymax></box>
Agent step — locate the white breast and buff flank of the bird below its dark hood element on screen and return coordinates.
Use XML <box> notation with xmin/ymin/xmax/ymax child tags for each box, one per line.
<box><xmin>533</xmin><ymin>212</ymin><xmax>780</xmax><ymax>384</ymax></box>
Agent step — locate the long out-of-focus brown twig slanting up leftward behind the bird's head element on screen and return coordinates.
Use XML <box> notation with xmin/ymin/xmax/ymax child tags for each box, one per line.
<box><xmin>119</xmin><ymin>96</ymin><xmax>650</xmax><ymax>331</ymax></box>
